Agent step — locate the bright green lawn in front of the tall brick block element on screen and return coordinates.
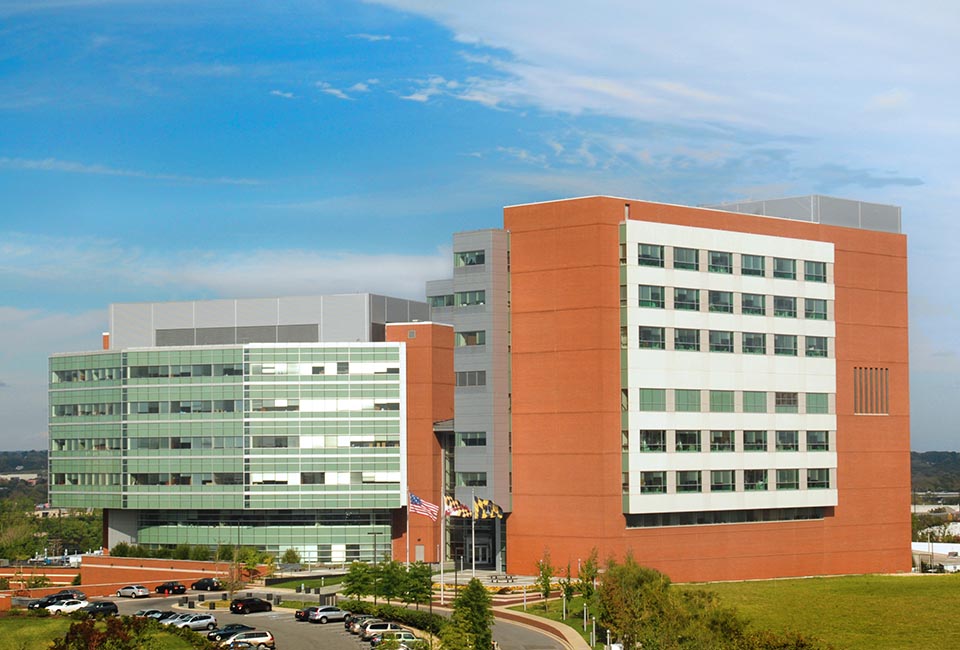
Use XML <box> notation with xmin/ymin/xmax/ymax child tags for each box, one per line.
<box><xmin>679</xmin><ymin>574</ymin><xmax>960</xmax><ymax>650</ymax></box>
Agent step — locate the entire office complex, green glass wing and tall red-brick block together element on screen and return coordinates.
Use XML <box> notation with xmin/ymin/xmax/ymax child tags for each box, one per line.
<box><xmin>50</xmin><ymin>196</ymin><xmax>910</xmax><ymax>580</ymax></box>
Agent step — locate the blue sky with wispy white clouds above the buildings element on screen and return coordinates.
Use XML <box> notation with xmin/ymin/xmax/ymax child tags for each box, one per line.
<box><xmin>0</xmin><ymin>0</ymin><xmax>960</xmax><ymax>450</ymax></box>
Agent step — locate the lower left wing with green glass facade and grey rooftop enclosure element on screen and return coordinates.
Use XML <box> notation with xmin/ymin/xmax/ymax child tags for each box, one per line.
<box><xmin>49</xmin><ymin>294</ymin><xmax>453</xmax><ymax>563</ymax></box>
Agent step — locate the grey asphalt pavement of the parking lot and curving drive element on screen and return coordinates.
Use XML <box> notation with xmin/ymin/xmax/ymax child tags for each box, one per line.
<box><xmin>103</xmin><ymin>593</ymin><xmax>564</xmax><ymax>650</ymax></box>
